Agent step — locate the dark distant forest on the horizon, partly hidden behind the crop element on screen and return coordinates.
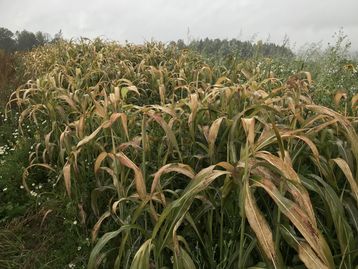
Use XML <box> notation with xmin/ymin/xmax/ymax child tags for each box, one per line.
<box><xmin>0</xmin><ymin>27</ymin><xmax>294</xmax><ymax>59</ymax></box>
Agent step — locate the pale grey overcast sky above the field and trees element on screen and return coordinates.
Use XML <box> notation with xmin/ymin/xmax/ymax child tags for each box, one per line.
<box><xmin>0</xmin><ymin>0</ymin><xmax>358</xmax><ymax>50</ymax></box>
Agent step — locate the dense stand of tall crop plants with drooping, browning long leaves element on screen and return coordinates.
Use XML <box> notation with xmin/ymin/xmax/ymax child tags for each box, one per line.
<box><xmin>6</xmin><ymin>40</ymin><xmax>358</xmax><ymax>269</ymax></box>
